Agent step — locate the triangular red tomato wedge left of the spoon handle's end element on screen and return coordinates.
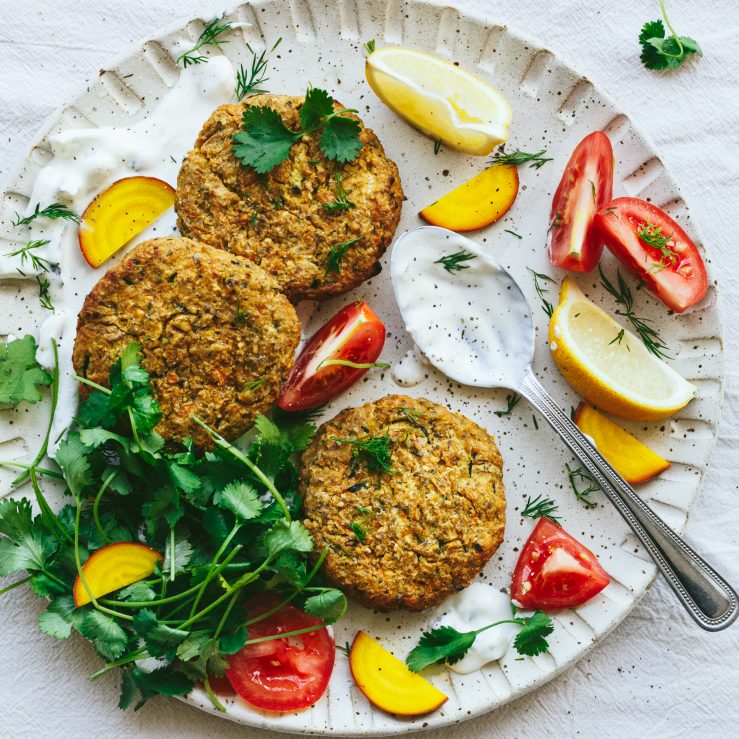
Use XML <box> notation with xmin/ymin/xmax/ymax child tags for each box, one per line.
<box><xmin>511</xmin><ymin>518</ymin><xmax>611</xmax><ymax>609</ymax></box>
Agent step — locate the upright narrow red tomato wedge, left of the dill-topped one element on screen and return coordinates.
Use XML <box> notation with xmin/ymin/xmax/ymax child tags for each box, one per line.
<box><xmin>547</xmin><ymin>131</ymin><xmax>613</xmax><ymax>272</ymax></box>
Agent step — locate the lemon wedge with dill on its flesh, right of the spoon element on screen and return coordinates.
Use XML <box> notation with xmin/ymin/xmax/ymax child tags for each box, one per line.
<box><xmin>549</xmin><ymin>277</ymin><xmax>695</xmax><ymax>421</ymax></box>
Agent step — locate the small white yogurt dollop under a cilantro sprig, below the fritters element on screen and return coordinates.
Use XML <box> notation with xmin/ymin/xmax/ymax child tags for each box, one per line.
<box><xmin>433</xmin><ymin>582</ymin><xmax>521</xmax><ymax>675</ymax></box>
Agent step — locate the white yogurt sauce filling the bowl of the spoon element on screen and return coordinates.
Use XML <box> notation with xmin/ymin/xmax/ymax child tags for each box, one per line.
<box><xmin>390</xmin><ymin>226</ymin><xmax>534</xmax><ymax>390</ymax></box>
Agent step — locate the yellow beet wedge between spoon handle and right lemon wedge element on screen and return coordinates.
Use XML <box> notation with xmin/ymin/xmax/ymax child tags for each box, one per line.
<box><xmin>575</xmin><ymin>403</ymin><xmax>670</xmax><ymax>483</ymax></box>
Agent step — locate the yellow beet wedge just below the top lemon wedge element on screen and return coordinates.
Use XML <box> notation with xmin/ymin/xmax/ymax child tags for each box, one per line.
<box><xmin>418</xmin><ymin>164</ymin><xmax>518</xmax><ymax>231</ymax></box>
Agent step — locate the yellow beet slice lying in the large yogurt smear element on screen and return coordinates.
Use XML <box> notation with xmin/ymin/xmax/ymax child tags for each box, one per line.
<box><xmin>79</xmin><ymin>177</ymin><xmax>174</xmax><ymax>267</ymax></box>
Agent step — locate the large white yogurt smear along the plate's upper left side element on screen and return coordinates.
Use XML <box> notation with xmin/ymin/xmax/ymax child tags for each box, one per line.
<box><xmin>0</xmin><ymin>56</ymin><xmax>234</xmax><ymax>454</ymax></box>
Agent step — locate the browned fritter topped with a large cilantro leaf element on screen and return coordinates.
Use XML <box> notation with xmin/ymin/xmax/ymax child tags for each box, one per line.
<box><xmin>175</xmin><ymin>94</ymin><xmax>403</xmax><ymax>302</ymax></box>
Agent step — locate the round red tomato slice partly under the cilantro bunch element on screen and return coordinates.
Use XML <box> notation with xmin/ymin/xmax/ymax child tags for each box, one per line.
<box><xmin>226</xmin><ymin>596</ymin><xmax>336</xmax><ymax>711</ymax></box>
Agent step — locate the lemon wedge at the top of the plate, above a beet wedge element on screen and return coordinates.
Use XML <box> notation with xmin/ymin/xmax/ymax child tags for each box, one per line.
<box><xmin>365</xmin><ymin>46</ymin><xmax>513</xmax><ymax>156</ymax></box>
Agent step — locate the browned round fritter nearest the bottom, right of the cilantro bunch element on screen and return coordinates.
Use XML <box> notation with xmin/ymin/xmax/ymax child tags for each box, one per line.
<box><xmin>300</xmin><ymin>395</ymin><xmax>505</xmax><ymax>611</ymax></box>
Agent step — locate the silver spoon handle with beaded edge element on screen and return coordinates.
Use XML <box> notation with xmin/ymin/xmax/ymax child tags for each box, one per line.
<box><xmin>519</xmin><ymin>370</ymin><xmax>739</xmax><ymax>631</ymax></box>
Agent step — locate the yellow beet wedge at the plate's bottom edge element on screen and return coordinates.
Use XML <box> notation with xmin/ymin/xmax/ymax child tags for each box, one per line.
<box><xmin>349</xmin><ymin>631</ymin><xmax>447</xmax><ymax>716</ymax></box>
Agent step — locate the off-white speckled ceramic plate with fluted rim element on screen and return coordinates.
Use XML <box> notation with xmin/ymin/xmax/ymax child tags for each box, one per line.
<box><xmin>0</xmin><ymin>0</ymin><xmax>723</xmax><ymax>735</ymax></box>
